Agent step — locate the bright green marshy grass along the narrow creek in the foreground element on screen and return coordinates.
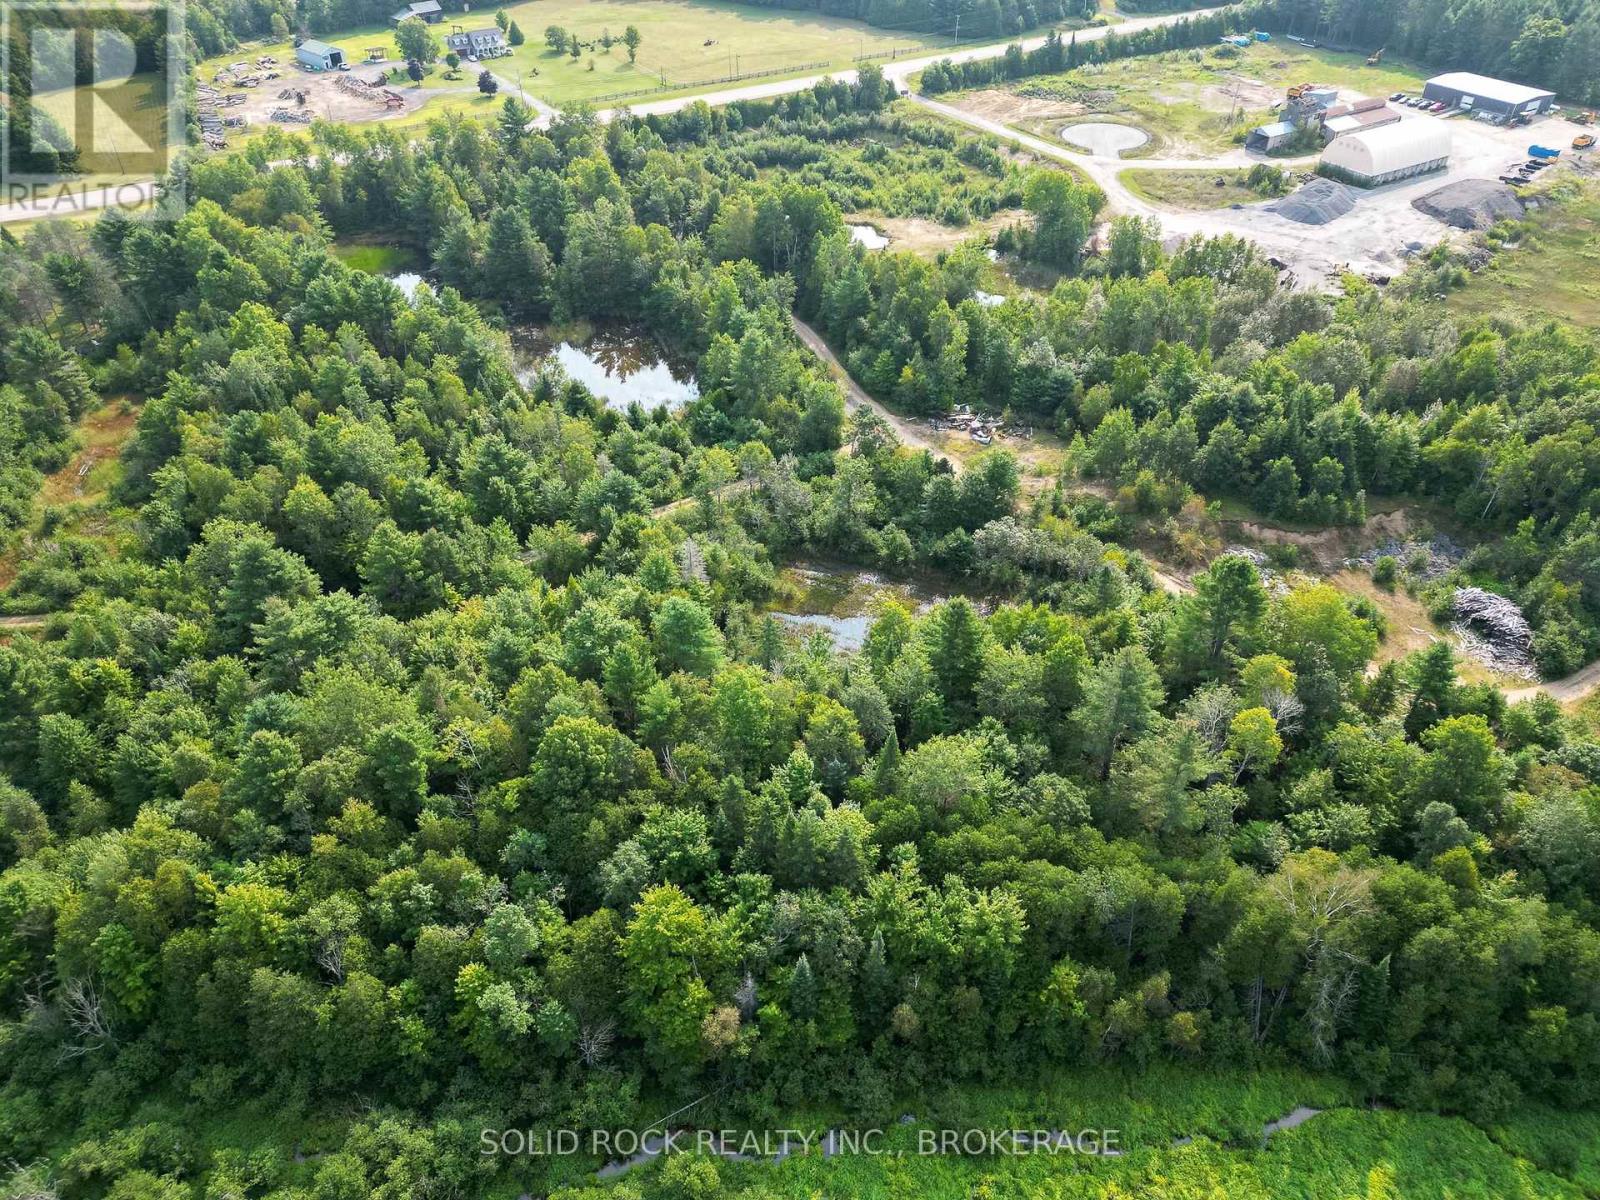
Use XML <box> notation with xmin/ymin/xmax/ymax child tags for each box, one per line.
<box><xmin>21</xmin><ymin>1064</ymin><xmax>1600</xmax><ymax>1200</ymax></box>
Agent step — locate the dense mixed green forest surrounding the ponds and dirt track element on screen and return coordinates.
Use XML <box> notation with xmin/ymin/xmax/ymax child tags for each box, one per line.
<box><xmin>0</xmin><ymin>70</ymin><xmax>1600</xmax><ymax>1200</ymax></box>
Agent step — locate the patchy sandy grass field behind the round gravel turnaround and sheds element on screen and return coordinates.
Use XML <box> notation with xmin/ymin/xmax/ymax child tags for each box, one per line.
<box><xmin>955</xmin><ymin>42</ymin><xmax>1426</xmax><ymax>160</ymax></box>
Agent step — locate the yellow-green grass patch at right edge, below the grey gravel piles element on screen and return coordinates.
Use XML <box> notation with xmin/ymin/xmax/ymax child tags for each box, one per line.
<box><xmin>1448</xmin><ymin>179</ymin><xmax>1600</xmax><ymax>330</ymax></box>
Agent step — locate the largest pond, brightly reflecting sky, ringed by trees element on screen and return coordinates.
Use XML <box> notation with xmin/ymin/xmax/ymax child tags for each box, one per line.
<box><xmin>512</xmin><ymin>325</ymin><xmax>699</xmax><ymax>413</ymax></box>
